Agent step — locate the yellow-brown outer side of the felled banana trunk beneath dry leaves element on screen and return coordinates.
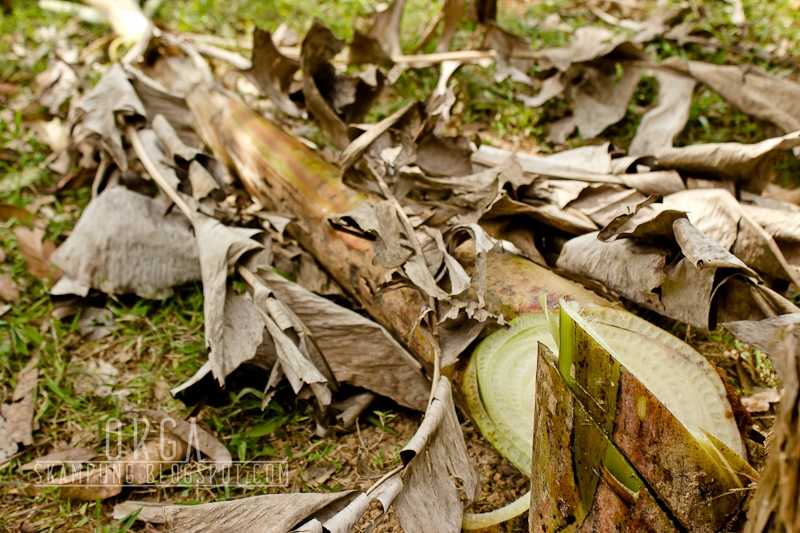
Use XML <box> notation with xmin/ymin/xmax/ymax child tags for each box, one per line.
<box><xmin>180</xmin><ymin>85</ymin><xmax>608</xmax><ymax>372</ymax></box>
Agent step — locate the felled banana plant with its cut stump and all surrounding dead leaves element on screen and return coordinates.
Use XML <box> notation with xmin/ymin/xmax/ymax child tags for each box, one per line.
<box><xmin>0</xmin><ymin>0</ymin><xmax>800</xmax><ymax>533</ymax></box>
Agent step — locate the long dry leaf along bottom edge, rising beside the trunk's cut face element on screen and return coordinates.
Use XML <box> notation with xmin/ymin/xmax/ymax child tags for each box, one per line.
<box><xmin>164</xmin><ymin>378</ymin><xmax>480</xmax><ymax>533</ymax></box>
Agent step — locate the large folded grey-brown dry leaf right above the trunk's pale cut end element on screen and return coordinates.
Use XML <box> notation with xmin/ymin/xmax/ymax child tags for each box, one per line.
<box><xmin>558</xmin><ymin>203</ymin><xmax>797</xmax><ymax>330</ymax></box>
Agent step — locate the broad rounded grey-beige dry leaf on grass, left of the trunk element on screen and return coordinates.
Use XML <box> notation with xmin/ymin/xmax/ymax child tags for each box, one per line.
<box><xmin>53</xmin><ymin>187</ymin><xmax>201</xmax><ymax>298</ymax></box>
